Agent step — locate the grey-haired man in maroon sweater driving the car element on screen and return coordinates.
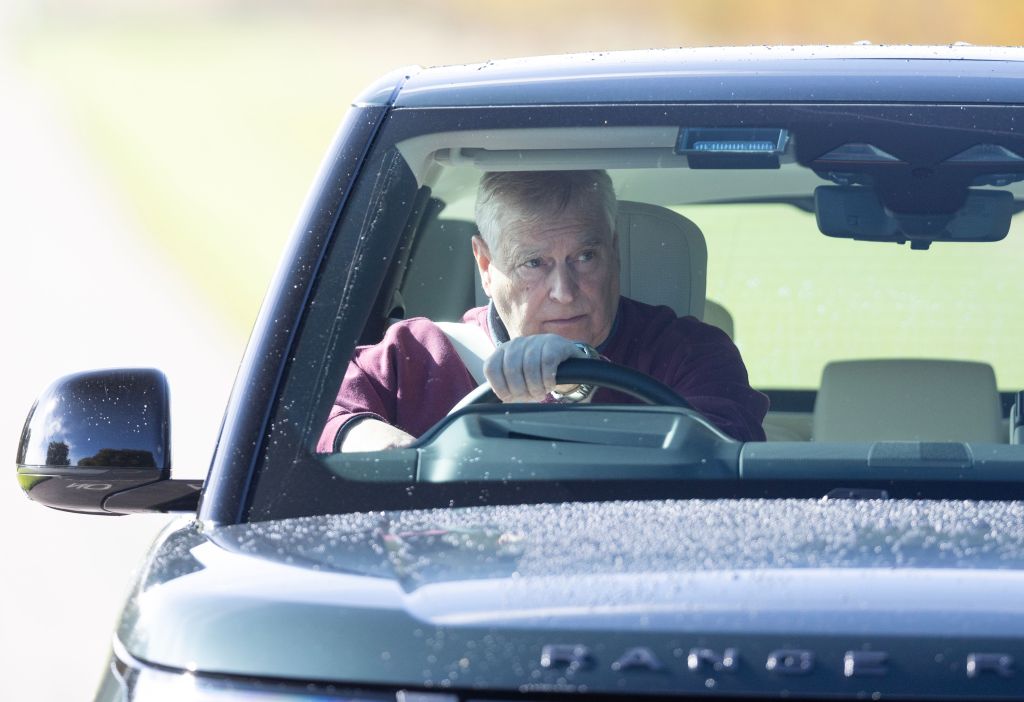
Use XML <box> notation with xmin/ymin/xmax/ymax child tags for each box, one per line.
<box><xmin>318</xmin><ymin>171</ymin><xmax>768</xmax><ymax>452</ymax></box>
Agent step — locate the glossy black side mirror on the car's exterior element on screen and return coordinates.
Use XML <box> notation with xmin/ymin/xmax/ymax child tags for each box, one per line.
<box><xmin>17</xmin><ymin>368</ymin><xmax>203</xmax><ymax>515</ymax></box>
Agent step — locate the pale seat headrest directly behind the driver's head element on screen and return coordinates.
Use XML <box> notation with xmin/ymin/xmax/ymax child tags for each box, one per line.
<box><xmin>476</xmin><ymin>201</ymin><xmax>708</xmax><ymax>319</ymax></box>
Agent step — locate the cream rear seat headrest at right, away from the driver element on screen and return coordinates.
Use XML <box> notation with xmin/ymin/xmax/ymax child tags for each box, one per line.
<box><xmin>812</xmin><ymin>359</ymin><xmax>1007</xmax><ymax>443</ymax></box>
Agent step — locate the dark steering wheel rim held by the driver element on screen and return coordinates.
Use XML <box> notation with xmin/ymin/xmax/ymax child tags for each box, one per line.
<box><xmin>449</xmin><ymin>358</ymin><xmax>696</xmax><ymax>414</ymax></box>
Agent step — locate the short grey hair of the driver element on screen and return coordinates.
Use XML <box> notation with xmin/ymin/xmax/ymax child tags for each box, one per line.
<box><xmin>475</xmin><ymin>171</ymin><xmax>617</xmax><ymax>251</ymax></box>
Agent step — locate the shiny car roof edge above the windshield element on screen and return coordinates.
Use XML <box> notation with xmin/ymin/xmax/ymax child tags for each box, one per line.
<box><xmin>356</xmin><ymin>44</ymin><xmax>1024</xmax><ymax>107</ymax></box>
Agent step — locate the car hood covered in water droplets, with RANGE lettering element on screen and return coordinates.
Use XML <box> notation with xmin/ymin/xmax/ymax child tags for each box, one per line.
<box><xmin>118</xmin><ymin>499</ymin><xmax>1024</xmax><ymax>695</ymax></box>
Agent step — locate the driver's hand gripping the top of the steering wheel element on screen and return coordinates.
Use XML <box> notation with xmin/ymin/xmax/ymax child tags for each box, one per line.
<box><xmin>483</xmin><ymin>334</ymin><xmax>587</xmax><ymax>402</ymax></box>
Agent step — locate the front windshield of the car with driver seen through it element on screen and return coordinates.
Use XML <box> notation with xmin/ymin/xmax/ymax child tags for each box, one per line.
<box><xmin>243</xmin><ymin>104</ymin><xmax>1024</xmax><ymax>519</ymax></box>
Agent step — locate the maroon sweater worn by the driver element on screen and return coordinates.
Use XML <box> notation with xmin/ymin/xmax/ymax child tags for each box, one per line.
<box><xmin>316</xmin><ymin>298</ymin><xmax>768</xmax><ymax>452</ymax></box>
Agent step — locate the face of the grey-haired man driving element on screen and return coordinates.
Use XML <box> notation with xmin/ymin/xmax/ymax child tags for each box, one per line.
<box><xmin>473</xmin><ymin>212</ymin><xmax>618</xmax><ymax>346</ymax></box>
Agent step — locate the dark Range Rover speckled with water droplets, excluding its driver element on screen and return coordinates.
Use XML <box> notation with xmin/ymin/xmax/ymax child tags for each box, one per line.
<box><xmin>17</xmin><ymin>45</ymin><xmax>1024</xmax><ymax>702</ymax></box>
